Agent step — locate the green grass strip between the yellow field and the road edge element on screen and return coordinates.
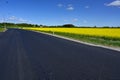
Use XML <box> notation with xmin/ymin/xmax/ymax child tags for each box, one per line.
<box><xmin>38</xmin><ymin>31</ymin><xmax>120</xmax><ymax>47</ymax></box>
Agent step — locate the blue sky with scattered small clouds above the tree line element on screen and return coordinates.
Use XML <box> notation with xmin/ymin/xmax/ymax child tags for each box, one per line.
<box><xmin>0</xmin><ymin>0</ymin><xmax>120</xmax><ymax>26</ymax></box>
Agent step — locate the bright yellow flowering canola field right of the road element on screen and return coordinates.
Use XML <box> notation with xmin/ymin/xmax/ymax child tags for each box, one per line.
<box><xmin>24</xmin><ymin>28</ymin><xmax>120</xmax><ymax>39</ymax></box>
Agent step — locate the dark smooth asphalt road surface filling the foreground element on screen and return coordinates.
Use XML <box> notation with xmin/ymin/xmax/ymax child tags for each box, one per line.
<box><xmin>0</xmin><ymin>29</ymin><xmax>120</xmax><ymax>80</ymax></box>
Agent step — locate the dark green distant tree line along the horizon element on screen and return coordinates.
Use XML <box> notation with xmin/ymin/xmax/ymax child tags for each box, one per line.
<box><xmin>0</xmin><ymin>23</ymin><xmax>120</xmax><ymax>28</ymax></box>
